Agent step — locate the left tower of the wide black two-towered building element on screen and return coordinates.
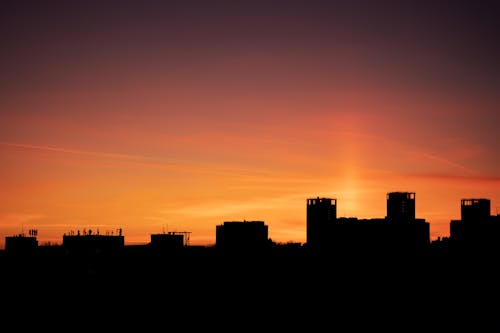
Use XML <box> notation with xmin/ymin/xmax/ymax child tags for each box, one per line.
<box><xmin>306</xmin><ymin>197</ymin><xmax>337</xmax><ymax>248</ymax></box>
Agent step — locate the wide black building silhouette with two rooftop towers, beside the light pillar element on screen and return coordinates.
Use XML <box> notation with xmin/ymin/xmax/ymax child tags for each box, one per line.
<box><xmin>306</xmin><ymin>192</ymin><xmax>430</xmax><ymax>259</ymax></box>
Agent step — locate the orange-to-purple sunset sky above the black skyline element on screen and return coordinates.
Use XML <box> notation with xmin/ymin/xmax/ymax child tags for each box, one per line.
<box><xmin>0</xmin><ymin>0</ymin><xmax>500</xmax><ymax>248</ymax></box>
